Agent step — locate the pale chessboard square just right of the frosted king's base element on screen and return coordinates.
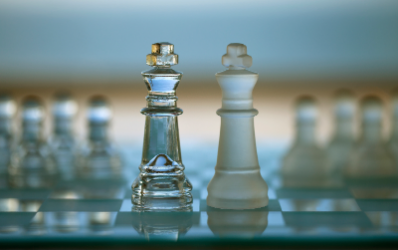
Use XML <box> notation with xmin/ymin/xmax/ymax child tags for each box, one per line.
<box><xmin>279</xmin><ymin>199</ymin><xmax>360</xmax><ymax>212</ymax></box>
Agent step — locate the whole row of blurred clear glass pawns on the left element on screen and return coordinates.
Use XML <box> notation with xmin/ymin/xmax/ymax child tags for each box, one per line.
<box><xmin>0</xmin><ymin>94</ymin><xmax>121</xmax><ymax>187</ymax></box>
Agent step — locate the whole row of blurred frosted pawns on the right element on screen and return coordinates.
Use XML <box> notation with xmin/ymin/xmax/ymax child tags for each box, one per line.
<box><xmin>281</xmin><ymin>90</ymin><xmax>398</xmax><ymax>180</ymax></box>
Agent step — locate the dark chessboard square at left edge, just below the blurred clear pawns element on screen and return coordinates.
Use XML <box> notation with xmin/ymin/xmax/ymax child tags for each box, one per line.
<box><xmin>0</xmin><ymin>189</ymin><xmax>51</xmax><ymax>200</ymax></box>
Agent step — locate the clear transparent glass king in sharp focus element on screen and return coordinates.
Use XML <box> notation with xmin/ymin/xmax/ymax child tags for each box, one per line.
<box><xmin>131</xmin><ymin>43</ymin><xmax>192</xmax><ymax>210</ymax></box>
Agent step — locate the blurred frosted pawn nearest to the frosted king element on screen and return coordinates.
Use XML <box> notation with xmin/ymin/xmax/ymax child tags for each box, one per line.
<box><xmin>281</xmin><ymin>96</ymin><xmax>326</xmax><ymax>186</ymax></box>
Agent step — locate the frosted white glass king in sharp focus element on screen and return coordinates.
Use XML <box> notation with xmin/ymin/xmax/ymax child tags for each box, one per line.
<box><xmin>207</xmin><ymin>43</ymin><xmax>268</xmax><ymax>209</ymax></box>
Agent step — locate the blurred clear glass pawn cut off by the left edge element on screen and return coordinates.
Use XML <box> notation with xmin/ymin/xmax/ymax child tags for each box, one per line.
<box><xmin>0</xmin><ymin>93</ymin><xmax>16</xmax><ymax>174</ymax></box>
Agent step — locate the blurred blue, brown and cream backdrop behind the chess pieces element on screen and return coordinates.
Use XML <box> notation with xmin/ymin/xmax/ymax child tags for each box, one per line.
<box><xmin>0</xmin><ymin>0</ymin><xmax>398</xmax><ymax>146</ymax></box>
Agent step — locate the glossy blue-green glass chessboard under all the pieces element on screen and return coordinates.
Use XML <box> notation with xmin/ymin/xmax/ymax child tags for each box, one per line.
<box><xmin>0</xmin><ymin>143</ymin><xmax>398</xmax><ymax>247</ymax></box>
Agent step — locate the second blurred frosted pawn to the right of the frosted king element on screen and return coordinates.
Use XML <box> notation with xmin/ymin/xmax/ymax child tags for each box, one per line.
<box><xmin>326</xmin><ymin>90</ymin><xmax>356</xmax><ymax>175</ymax></box>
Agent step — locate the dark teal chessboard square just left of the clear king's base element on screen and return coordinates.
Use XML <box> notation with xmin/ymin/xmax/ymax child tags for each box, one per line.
<box><xmin>40</xmin><ymin>199</ymin><xmax>122</xmax><ymax>212</ymax></box>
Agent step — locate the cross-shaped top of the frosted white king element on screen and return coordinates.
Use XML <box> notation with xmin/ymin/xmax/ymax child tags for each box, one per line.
<box><xmin>222</xmin><ymin>43</ymin><xmax>253</xmax><ymax>70</ymax></box>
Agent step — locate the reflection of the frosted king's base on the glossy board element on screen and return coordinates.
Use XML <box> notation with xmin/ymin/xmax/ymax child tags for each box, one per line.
<box><xmin>207</xmin><ymin>210</ymin><xmax>268</xmax><ymax>238</ymax></box>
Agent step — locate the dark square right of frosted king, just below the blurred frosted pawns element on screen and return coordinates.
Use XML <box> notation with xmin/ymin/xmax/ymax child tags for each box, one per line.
<box><xmin>276</xmin><ymin>188</ymin><xmax>353</xmax><ymax>199</ymax></box>
